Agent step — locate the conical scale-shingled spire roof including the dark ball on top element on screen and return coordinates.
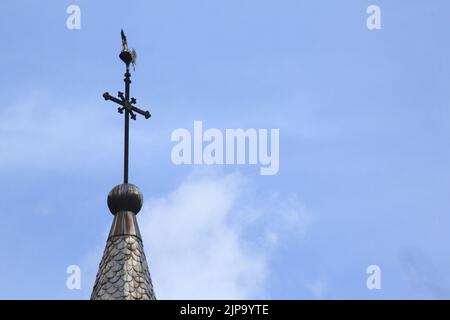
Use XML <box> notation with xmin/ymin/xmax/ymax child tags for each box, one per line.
<box><xmin>91</xmin><ymin>183</ymin><xmax>156</xmax><ymax>300</ymax></box>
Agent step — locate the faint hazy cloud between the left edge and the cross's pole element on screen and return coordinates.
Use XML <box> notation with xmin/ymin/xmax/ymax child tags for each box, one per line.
<box><xmin>0</xmin><ymin>94</ymin><xmax>120</xmax><ymax>169</ymax></box>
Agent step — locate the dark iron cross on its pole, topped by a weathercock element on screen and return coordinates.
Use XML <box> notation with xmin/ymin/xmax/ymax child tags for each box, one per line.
<box><xmin>103</xmin><ymin>30</ymin><xmax>151</xmax><ymax>183</ymax></box>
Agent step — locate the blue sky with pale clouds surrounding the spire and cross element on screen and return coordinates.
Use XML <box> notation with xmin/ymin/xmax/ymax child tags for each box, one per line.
<box><xmin>0</xmin><ymin>0</ymin><xmax>450</xmax><ymax>299</ymax></box>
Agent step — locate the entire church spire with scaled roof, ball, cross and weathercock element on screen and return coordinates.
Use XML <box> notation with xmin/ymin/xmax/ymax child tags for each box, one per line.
<box><xmin>91</xmin><ymin>30</ymin><xmax>156</xmax><ymax>300</ymax></box>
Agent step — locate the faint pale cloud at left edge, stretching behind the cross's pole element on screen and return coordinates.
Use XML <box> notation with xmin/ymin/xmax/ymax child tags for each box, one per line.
<box><xmin>0</xmin><ymin>93</ymin><xmax>161</xmax><ymax>172</ymax></box>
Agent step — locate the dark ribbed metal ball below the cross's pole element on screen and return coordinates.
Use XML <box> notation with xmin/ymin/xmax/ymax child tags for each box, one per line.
<box><xmin>108</xmin><ymin>183</ymin><xmax>144</xmax><ymax>215</ymax></box>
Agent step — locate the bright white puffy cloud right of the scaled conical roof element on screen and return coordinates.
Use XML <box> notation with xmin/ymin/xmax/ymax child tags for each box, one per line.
<box><xmin>139</xmin><ymin>174</ymin><xmax>310</xmax><ymax>299</ymax></box>
